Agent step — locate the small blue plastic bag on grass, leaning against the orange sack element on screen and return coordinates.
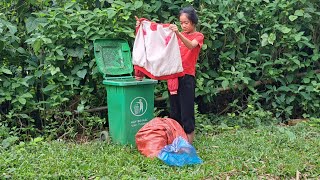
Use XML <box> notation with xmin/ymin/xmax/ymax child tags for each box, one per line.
<box><xmin>158</xmin><ymin>136</ymin><xmax>202</xmax><ymax>166</ymax></box>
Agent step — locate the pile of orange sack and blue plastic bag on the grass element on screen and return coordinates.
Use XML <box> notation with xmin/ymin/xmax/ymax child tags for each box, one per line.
<box><xmin>135</xmin><ymin>117</ymin><xmax>202</xmax><ymax>166</ymax></box>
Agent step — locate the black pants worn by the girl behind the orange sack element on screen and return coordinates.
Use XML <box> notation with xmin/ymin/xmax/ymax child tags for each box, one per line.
<box><xmin>169</xmin><ymin>74</ymin><xmax>195</xmax><ymax>134</ymax></box>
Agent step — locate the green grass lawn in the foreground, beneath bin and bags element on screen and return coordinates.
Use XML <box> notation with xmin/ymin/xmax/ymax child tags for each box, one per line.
<box><xmin>0</xmin><ymin>124</ymin><xmax>320</xmax><ymax>179</ymax></box>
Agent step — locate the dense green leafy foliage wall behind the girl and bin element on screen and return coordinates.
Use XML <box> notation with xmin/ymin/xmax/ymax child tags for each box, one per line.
<box><xmin>0</xmin><ymin>0</ymin><xmax>320</xmax><ymax>137</ymax></box>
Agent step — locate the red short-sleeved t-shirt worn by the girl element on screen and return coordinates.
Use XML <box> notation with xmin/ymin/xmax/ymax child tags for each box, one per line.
<box><xmin>178</xmin><ymin>32</ymin><xmax>204</xmax><ymax>76</ymax></box>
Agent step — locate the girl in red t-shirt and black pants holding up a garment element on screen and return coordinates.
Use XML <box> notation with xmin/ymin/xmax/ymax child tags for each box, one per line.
<box><xmin>169</xmin><ymin>7</ymin><xmax>204</xmax><ymax>143</ymax></box>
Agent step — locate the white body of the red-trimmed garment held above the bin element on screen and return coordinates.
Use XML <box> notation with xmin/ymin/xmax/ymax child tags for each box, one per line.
<box><xmin>132</xmin><ymin>20</ymin><xmax>183</xmax><ymax>77</ymax></box>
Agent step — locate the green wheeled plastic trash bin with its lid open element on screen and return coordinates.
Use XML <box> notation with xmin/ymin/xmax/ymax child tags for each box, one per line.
<box><xmin>94</xmin><ymin>39</ymin><xmax>157</xmax><ymax>145</ymax></box>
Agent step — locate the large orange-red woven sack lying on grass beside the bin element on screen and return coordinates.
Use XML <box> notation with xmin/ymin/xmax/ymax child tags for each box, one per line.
<box><xmin>136</xmin><ymin>117</ymin><xmax>188</xmax><ymax>158</ymax></box>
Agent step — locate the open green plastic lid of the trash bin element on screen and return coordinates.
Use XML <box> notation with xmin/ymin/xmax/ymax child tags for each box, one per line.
<box><xmin>93</xmin><ymin>39</ymin><xmax>133</xmax><ymax>77</ymax></box>
